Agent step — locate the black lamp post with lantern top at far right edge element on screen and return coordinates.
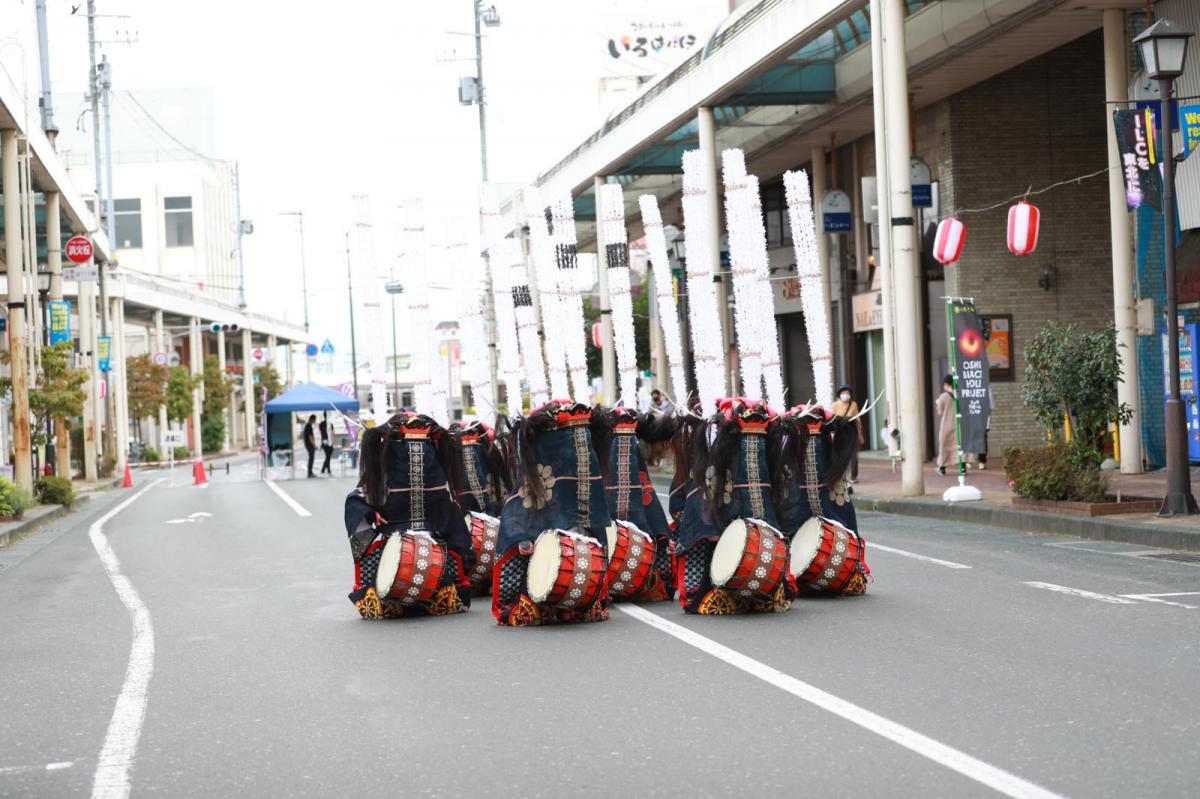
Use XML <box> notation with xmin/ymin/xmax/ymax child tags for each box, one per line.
<box><xmin>1133</xmin><ymin>19</ymin><xmax>1196</xmax><ymax>516</ymax></box>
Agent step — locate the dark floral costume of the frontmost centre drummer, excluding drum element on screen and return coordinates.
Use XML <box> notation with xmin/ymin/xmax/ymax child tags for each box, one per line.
<box><xmin>492</xmin><ymin>402</ymin><xmax>612</xmax><ymax>627</ymax></box>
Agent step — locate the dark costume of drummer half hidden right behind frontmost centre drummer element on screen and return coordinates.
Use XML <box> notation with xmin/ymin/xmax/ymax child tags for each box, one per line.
<box><xmin>605</xmin><ymin>408</ymin><xmax>674</xmax><ymax>602</ymax></box>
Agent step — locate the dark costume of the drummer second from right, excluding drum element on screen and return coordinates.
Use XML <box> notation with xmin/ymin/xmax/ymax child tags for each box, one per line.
<box><xmin>676</xmin><ymin>402</ymin><xmax>791</xmax><ymax>615</ymax></box>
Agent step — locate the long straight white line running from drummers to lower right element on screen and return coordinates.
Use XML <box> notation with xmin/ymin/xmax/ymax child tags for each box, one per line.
<box><xmin>614</xmin><ymin>605</ymin><xmax>1060</xmax><ymax>799</ymax></box>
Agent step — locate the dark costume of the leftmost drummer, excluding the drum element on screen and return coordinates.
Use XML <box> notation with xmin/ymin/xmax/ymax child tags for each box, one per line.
<box><xmin>346</xmin><ymin>414</ymin><xmax>473</xmax><ymax>619</ymax></box>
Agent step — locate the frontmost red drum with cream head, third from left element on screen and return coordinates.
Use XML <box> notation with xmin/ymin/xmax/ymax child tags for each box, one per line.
<box><xmin>526</xmin><ymin>530</ymin><xmax>608</xmax><ymax>609</ymax></box>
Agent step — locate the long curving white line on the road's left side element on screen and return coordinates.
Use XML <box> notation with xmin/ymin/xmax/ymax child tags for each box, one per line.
<box><xmin>88</xmin><ymin>479</ymin><xmax>162</xmax><ymax>799</ymax></box>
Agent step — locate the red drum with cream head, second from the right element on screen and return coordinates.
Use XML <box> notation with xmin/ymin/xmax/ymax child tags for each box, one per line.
<box><xmin>709</xmin><ymin>518</ymin><xmax>787</xmax><ymax>597</ymax></box>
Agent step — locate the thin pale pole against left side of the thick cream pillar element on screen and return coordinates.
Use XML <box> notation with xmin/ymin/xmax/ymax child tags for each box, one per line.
<box><xmin>870</xmin><ymin>0</ymin><xmax>902</xmax><ymax>458</ymax></box>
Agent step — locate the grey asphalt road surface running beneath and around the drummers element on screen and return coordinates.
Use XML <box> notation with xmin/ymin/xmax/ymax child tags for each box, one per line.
<box><xmin>0</xmin><ymin>463</ymin><xmax>1200</xmax><ymax>797</ymax></box>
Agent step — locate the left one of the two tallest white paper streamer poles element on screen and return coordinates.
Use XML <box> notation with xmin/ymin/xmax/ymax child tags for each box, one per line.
<box><xmin>683</xmin><ymin>150</ymin><xmax>725</xmax><ymax>415</ymax></box>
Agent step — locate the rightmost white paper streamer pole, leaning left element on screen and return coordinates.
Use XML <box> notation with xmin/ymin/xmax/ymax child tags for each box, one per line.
<box><xmin>784</xmin><ymin>170</ymin><xmax>833</xmax><ymax>409</ymax></box>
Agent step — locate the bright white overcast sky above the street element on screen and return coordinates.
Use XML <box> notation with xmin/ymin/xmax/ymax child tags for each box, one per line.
<box><xmin>0</xmin><ymin>0</ymin><xmax>727</xmax><ymax>364</ymax></box>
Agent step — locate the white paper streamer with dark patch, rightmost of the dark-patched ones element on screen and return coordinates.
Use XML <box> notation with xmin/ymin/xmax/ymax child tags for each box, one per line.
<box><xmin>596</xmin><ymin>184</ymin><xmax>637</xmax><ymax>408</ymax></box>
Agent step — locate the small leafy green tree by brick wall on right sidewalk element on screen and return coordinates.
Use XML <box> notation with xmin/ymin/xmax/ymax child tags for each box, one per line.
<box><xmin>1021</xmin><ymin>322</ymin><xmax>1133</xmax><ymax>464</ymax></box>
